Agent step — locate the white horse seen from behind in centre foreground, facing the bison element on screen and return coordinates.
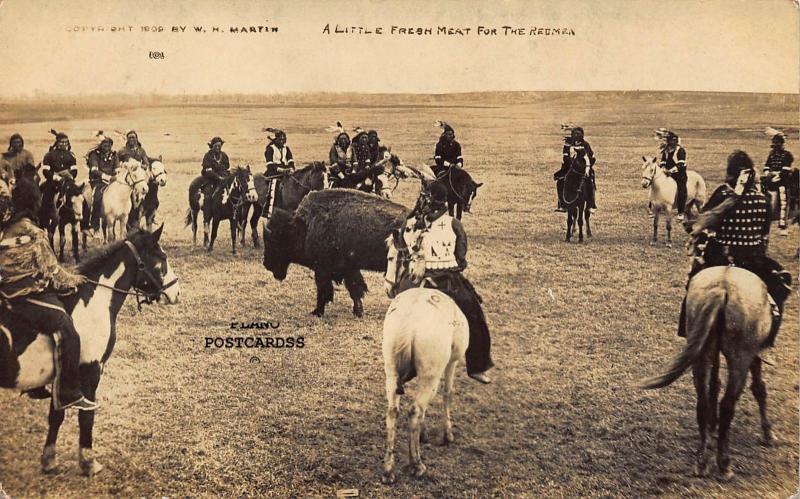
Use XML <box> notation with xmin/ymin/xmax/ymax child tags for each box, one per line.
<box><xmin>382</xmin><ymin>223</ymin><xmax>469</xmax><ymax>483</ymax></box>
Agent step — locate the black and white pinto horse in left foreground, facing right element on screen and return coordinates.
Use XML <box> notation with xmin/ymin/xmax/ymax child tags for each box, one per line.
<box><xmin>0</xmin><ymin>228</ymin><xmax>180</xmax><ymax>476</ymax></box>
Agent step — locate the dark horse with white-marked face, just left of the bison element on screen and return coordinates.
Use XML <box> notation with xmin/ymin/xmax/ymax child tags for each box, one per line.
<box><xmin>186</xmin><ymin>165</ymin><xmax>258</xmax><ymax>255</ymax></box>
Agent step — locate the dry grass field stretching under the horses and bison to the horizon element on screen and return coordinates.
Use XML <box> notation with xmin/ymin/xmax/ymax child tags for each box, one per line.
<box><xmin>0</xmin><ymin>93</ymin><xmax>800</xmax><ymax>498</ymax></box>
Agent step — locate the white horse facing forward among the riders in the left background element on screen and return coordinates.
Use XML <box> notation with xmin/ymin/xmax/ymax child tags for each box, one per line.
<box><xmin>103</xmin><ymin>158</ymin><xmax>149</xmax><ymax>243</ymax></box>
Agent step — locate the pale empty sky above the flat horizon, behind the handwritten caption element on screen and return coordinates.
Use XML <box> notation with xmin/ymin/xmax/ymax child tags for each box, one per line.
<box><xmin>0</xmin><ymin>0</ymin><xmax>800</xmax><ymax>97</ymax></box>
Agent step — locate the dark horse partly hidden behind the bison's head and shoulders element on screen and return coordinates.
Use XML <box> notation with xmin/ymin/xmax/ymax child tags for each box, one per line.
<box><xmin>239</xmin><ymin>161</ymin><xmax>329</xmax><ymax>248</ymax></box>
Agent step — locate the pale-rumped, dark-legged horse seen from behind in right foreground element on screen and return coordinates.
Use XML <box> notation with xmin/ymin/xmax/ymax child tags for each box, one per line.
<box><xmin>642</xmin><ymin>267</ymin><xmax>774</xmax><ymax>480</ymax></box>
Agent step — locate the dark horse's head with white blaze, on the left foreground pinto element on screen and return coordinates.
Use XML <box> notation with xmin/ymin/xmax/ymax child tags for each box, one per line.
<box><xmin>125</xmin><ymin>225</ymin><xmax>181</xmax><ymax>304</ymax></box>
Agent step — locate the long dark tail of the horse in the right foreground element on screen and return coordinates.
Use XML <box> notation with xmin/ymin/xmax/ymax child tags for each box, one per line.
<box><xmin>639</xmin><ymin>288</ymin><xmax>728</xmax><ymax>389</ymax></box>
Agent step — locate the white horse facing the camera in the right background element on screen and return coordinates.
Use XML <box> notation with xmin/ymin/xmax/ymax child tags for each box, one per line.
<box><xmin>642</xmin><ymin>156</ymin><xmax>706</xmax><ymax>247</ymax></box>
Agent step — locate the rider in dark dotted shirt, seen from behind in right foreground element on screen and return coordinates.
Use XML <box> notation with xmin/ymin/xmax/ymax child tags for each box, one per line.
<box><xmin>678</xmin><ymin>151</ymin><xmax>791</xmax><ymax>360</ymax></box>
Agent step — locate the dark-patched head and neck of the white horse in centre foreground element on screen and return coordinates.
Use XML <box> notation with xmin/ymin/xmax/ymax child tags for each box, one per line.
<box><xmin>383</xmin><ymin>218</ymin><xmax>425</xmax><ymax>298</ymax></box>
